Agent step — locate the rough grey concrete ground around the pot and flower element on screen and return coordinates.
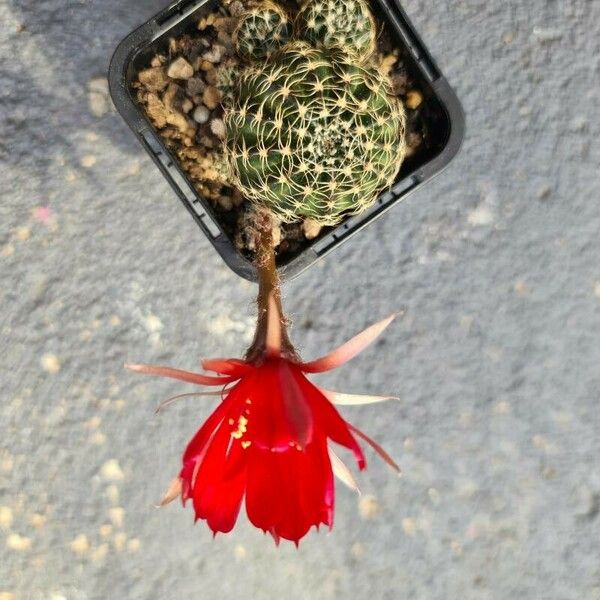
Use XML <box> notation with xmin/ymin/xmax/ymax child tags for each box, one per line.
<box><xmin>0</xmin><ymin>0</ymin><xmax>600</xmax><ymax>600</ymax></box>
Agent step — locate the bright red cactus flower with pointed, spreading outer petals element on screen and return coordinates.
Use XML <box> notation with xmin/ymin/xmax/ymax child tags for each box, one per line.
<box><xmin>129</xmin><ymin>312</ymin><xmax>399</xmax><ymax>544</ymax></box>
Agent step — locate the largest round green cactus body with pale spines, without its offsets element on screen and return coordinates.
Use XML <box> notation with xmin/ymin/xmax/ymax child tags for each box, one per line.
<box><xmin>224</xmin><ymin>42</ymin><xmax>405</xmax><ymax>225</ymax></box>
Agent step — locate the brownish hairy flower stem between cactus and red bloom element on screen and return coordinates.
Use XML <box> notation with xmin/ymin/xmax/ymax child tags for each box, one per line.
<box><xmin>246</xmin><ymin>211</ymin><xmax>299</xmax><ymax>364</ymax></box>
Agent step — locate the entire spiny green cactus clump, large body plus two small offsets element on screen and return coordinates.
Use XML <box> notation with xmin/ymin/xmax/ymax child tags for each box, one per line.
<box><xmin>224</xmin><ymin>0</ymin><xmax>405</xmax><ymax>225</ymax></box>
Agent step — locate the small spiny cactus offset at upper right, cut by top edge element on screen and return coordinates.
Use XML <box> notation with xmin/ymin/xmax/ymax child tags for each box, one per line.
<box><xmin>295</xmin><ymin>0</ymin><xmax>377</xmax><ymax>62</ymax></box>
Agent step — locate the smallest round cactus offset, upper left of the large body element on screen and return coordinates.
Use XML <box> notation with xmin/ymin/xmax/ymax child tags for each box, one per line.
<box><xmin>233</xmin><ymin>2</ymin><xmax>292</xmax><ymax>60</ymax></box>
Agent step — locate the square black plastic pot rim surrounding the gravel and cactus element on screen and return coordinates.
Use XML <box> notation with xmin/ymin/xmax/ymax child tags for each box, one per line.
<box><xmin>109</xmin><ymin>0</ymin><xmax>465</xmax><ymax>281</ymax></box>
